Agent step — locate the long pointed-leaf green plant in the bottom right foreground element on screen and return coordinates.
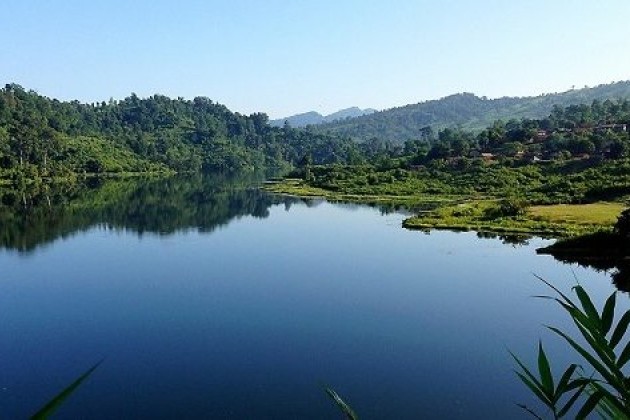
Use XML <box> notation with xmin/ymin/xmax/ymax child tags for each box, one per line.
<box><xmin>512</xmin><ymin>277</ymin><xmax>630</xmax><ymax>420</ymax></box>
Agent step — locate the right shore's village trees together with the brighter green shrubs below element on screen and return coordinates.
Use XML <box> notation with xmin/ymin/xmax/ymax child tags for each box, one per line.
<box><xmin>294</xmin><ymin>100</ymin><xmax>630</xmax><ymax>204</ymax></box>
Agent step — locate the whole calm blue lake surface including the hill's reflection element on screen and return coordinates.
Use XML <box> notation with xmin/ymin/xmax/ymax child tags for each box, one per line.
<box><xmin>0</xmin><ymin>178</ymin><xmax>627</xmax><ymax>419</ymax></box>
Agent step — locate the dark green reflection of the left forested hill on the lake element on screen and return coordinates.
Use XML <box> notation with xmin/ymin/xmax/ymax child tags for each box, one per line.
<box><xmin>0</xmin><ymin>175</ymin><xmax>295</xmax><ymax>251</ymax></box>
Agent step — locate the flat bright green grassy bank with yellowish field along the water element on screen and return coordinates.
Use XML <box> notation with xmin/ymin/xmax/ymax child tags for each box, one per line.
<box><xmin>263</xmin><ymin>179</ymin><xmax>625</xmax><ymax>238</ymax></box>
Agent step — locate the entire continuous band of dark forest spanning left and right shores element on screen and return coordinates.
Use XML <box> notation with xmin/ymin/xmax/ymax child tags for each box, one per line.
<box><xmin>0</xmin><ymin>83</ymin><xmax>630</xmax><ymax>189</ymax></box>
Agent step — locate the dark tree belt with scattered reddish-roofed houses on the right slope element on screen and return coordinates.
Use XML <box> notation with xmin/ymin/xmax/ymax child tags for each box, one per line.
<box><xmin>318</xmin><ymin>100</ymin><xmax>630</xmax><ymax>168</ymax></box>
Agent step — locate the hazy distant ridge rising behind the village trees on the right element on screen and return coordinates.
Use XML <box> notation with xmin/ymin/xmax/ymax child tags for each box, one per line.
<box><xmin>312</xmin><ymin>81</ymin><xmax>630</xmax><ymax>142</ymax></box>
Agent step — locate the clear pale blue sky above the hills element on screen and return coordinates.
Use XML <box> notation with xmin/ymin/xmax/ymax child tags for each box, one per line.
<box><xmin>0</xmin><ymin>0</ymin><xmax>630</xmax><ymax>118</ymax></box>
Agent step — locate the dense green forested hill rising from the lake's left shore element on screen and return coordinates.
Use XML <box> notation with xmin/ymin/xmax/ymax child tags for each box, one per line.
<box><xmin>0</xmin><ymin>84</ymin><xmax>366</xmax><ymax>179</ymax></box>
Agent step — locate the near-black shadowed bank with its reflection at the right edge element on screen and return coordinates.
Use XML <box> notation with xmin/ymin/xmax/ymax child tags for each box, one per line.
<box><xmin>537</xmin><ymin>233</ymin><xmax>630</xmax><ymax>293</ymax></box>
